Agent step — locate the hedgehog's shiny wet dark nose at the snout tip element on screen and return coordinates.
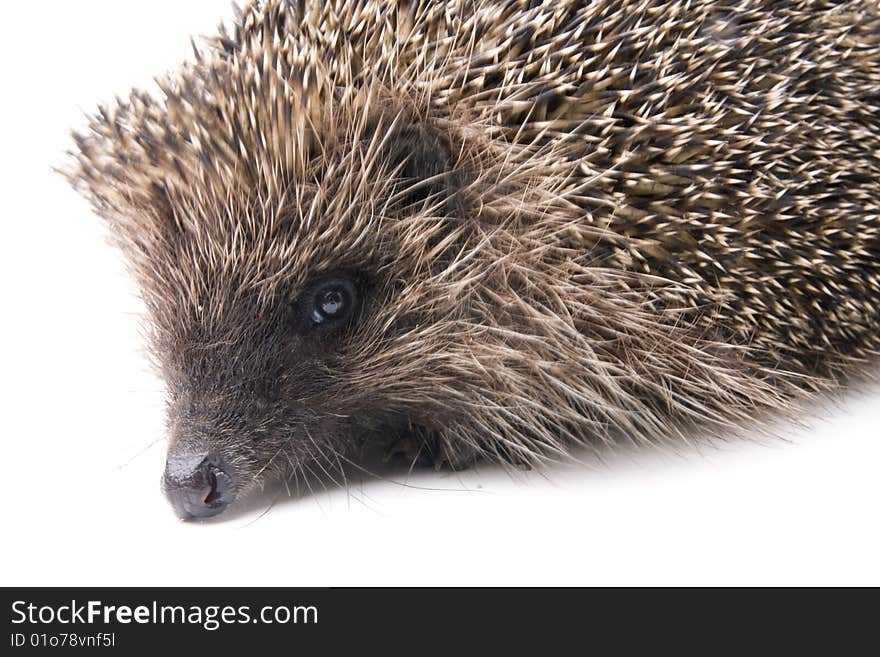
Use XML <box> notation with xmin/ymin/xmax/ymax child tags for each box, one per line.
<box><xmin>162</xmin><ymin>452</ymin><xmax>235</xmax><ymax>518</ymax></box>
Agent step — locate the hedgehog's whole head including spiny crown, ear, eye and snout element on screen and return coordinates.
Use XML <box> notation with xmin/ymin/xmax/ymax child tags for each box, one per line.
<box><xmin>65</xmin><ymin>18</ymin><xmax>532</xmax><ymax>517</ymax></box>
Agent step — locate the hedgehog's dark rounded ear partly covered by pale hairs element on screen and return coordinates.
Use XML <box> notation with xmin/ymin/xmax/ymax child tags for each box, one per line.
<box><xmin>385</xmin><ymin>124</ymin><xmax>460</xmax><ymax>216</ymax></box>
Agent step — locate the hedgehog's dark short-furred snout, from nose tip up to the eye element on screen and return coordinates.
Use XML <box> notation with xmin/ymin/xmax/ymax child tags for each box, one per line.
<box><xmin>158</xmin><ymin>270</ymin><xmax>378</xmax><ymax>517</ymax></box>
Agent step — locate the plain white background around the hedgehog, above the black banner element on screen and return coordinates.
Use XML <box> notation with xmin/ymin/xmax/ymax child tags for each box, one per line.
<box><xmin>0</xmin><ymin>0</ymin><xmax>880</xmax><ymax>585</ymax></box>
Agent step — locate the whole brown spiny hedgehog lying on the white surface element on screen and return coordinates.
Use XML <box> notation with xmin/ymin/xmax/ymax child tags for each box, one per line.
<box><xmin>66</xmin><ymin>0</ymin><xmax>880</xmax><ymax>518</ymax></box>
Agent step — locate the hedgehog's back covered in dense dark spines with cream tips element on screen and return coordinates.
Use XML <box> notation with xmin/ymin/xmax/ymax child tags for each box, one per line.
<box><xmin>408</xmin><ymin>0</ymin><xmax>880</xmax><ymax>372</ymax></box>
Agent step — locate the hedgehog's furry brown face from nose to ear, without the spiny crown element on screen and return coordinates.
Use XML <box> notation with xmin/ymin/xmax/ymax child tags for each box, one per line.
<box><xmin>156</xmin><ymin>119</ymin><xmax>478</xmax><ymax>517</ymax></box>
